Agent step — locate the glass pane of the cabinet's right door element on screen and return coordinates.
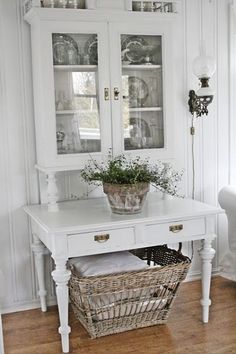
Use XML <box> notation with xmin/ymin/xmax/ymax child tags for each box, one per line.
<box><xmin>121</xmin><ymin>34</ymin><xmax>164</xmax><ymax>150</ymax></box>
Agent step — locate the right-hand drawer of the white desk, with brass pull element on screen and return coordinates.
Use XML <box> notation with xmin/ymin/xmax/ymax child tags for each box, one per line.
<box><xmin>141</xmin><ymin>218</ymin><xmax>206</xmax><ymax>243</ymax></box>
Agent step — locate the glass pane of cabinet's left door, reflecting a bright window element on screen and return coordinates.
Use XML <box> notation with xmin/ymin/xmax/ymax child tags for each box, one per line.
<box><xmin>52</xmin><ymin>33</ymin><xmax>101</xmax><ymax>154</ymax></box>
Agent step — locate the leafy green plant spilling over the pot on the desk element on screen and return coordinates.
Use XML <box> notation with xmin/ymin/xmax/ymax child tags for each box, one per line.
<box><xmin>81</xmin><ymin>155</ymin><xmax>183</xmax><ymax>195</ymax></box>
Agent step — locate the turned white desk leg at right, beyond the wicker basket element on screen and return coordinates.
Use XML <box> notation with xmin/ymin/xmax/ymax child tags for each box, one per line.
<box><xmin>199</xmin><ymin>239</ymin><xmax>215</xmax><ymax>323</ymax></box>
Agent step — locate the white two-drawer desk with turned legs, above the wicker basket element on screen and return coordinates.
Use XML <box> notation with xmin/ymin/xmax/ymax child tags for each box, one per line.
<box><xmin>24</xmin><ymin>193</ymin><xmax>222</xmax><ymax>353</ymax></box>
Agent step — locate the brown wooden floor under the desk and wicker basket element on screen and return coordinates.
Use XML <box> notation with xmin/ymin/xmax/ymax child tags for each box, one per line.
<box><xmin>3</xmin><ymin>277</ymin><xmax>236</xmax><ymax>354</ymax></box>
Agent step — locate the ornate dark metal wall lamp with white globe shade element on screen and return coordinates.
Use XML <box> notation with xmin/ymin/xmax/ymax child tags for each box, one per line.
<box><xmin>188</xmin><ymin>48</ymin><xmax>216</xmax><ymax>117</ymax></box>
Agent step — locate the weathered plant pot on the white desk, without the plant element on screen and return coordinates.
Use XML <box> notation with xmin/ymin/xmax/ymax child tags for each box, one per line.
<box><xmin>103</xmin><ymin>183</ymin><xmax>150</xmax><ymax>214</ymax></box>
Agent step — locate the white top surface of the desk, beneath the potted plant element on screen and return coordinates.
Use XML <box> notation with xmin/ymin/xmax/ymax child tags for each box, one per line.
<box><xmin>24</xmin><ymin>192</ymin><xmax>223</xmax><ymax>233</ymax></box>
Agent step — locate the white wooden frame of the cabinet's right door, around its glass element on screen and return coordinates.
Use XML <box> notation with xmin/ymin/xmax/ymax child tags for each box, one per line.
<box><xmin>109</xmin><ymin>19</ymin><xmax>175</xmax><ymax>161</ymax></box>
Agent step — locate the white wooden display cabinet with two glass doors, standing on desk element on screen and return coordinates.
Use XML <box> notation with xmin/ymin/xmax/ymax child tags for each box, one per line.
<box><xmin>25</xmin><ymin>7</ymin><xmax>176</xmax><ymax>210</ymax></box>
